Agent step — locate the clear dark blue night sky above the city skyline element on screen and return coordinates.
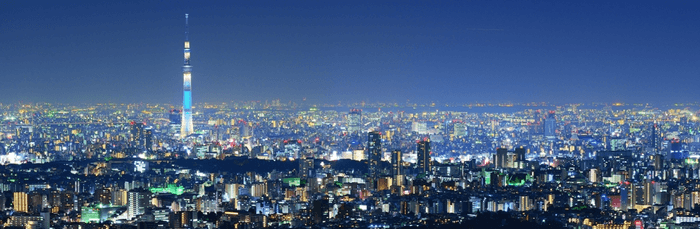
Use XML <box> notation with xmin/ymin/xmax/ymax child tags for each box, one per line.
<box><xmin>0</xmin><ymin>0</ymin><xmax>700</xmax><ymax>103</ymax></box>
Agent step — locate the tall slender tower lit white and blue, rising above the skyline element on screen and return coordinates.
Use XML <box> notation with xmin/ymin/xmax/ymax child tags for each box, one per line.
<box><xmin>180</xmin><ymin>14</ymin><xmax>194</xmax><ymax>138</ymax></box>
